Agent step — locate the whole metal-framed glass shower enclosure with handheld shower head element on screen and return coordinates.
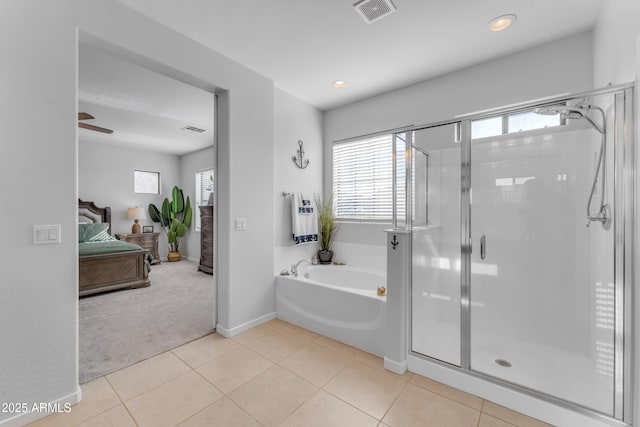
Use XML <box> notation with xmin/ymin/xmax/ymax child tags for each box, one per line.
<box><xmin>397</xmin><ymin>86</ymin><xmax>635</xmax><ymax>422</ymax></box>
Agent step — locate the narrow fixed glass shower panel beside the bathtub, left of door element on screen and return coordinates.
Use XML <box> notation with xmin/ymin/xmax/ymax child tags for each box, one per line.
<box><xmin>411</xmin><ymin>125</ymin><xmax>461</xmax><ymax>366</ymax></box>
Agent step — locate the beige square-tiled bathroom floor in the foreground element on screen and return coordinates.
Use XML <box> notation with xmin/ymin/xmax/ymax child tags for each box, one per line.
<box><xmin>31</xmin><ymin>320</ymin><xmax>547</xmax><ymax>427</ymax></box>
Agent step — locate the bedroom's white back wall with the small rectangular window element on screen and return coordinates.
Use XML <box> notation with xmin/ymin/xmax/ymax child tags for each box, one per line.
<box><xmin>78</xmin><ymin>140</ymin><xmax>181</xmax><ymax>259</ymax></box>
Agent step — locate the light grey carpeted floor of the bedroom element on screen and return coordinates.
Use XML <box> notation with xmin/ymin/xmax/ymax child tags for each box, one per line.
<box><xmin>79</xmin><ymin>260</ymin><xmax>214</xmax><ymax>384</ymax></box>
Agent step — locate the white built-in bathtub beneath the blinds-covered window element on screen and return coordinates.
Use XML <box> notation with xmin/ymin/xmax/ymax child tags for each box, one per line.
<box><xmin>276</xmin><ymin>265</ymin><xmax>387</xmax><ymax>357</ymax></box>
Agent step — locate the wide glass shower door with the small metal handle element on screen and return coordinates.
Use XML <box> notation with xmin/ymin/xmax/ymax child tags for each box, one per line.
<box><xmin>471</xmin><ymin>96</ymin><xmax>614</xmax><ymax>415</ymax></box>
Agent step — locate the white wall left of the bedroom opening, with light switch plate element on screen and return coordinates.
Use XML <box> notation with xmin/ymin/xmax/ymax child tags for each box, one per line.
<box><xmin>0</xmin><ymin>1</ymin><xmax>78</xmax><ymax>422</ymax></box>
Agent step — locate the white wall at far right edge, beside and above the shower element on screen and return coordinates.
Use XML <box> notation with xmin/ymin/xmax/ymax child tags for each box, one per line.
<box><xmin>593</xmin><ymin>0</ymin><xmax>640</xmax><ymax>425</ymax></box>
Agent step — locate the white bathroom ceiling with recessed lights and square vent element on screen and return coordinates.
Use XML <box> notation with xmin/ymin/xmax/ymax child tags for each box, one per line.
<box><xmin>119</xmin><ymin>0</ymin><xmax>601</xmax><ymax>110</ymax></box>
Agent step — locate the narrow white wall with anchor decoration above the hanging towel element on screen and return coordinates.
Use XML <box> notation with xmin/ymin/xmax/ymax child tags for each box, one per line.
<box><xmin>273</xmin><ymin>89</ymin><xmax>323</xmax><ymax>274</ymax></box>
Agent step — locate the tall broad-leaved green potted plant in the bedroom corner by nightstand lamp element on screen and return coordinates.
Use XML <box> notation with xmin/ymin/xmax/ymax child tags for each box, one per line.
<box><xmin>149</xmin><ymin>186</ymin><xmax>193</xmax><ymax>261</ymax></box>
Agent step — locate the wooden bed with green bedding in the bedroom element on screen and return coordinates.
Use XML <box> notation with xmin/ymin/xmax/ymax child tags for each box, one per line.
<box><xmin>78</xmin><ymin>200</ymin><xmax>151</xmax><ymax>297</ymax></box>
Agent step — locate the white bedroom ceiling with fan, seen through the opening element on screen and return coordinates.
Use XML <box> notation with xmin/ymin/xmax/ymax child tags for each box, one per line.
<box><xmin>78</xmin><ymin>44</ymin><xmax>214</xmax><ymax>155</ymax></box>
